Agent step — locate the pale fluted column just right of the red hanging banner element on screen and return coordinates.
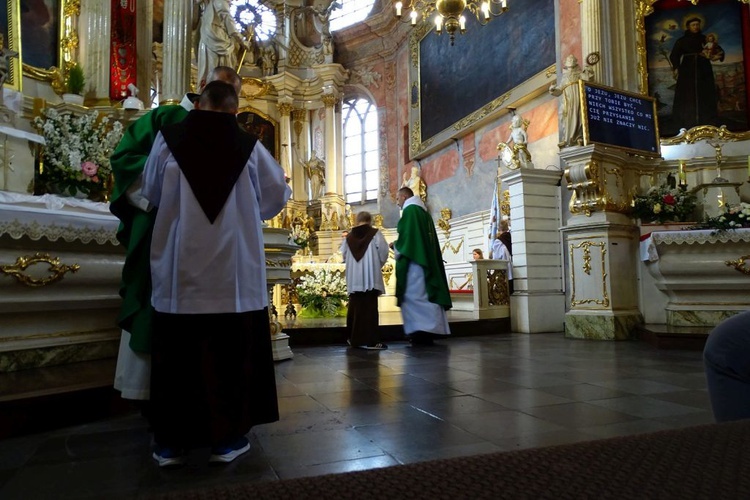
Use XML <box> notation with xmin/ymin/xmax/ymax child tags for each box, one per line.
<box><xmin>159</xmin><ymin>0</ymin><xmax>193</xmax><ymax>105</ymax></box>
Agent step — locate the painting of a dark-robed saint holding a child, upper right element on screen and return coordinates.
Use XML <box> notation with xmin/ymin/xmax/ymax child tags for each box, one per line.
<box><xmin>642</xmin><ymin>0</ymin><xmax>750</xmax><ymax>137</ymax></box>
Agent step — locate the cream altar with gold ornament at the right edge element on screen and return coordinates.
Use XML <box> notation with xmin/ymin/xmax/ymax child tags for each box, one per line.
<box><xmin>640</xmin><ymin>229</ymin><xmax>750</xmax><ymax>327</ymax></box>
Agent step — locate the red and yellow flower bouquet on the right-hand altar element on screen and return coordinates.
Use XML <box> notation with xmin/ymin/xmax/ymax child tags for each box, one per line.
<box><xmin>630</xmin><ymin>185</ymin><xmax>698</xmax><ymax>223</ymax></box>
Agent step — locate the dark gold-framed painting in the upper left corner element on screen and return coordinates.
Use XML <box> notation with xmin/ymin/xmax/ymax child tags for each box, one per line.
<box><xmin>20</xmin><ymin>0</ymin><xmax>64</xmax><ymax>69</ymax></box>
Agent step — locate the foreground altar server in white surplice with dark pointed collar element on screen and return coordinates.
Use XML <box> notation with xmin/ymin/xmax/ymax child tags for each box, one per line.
<box><xmin>143</xmin><ymin>81</ymin><xmax>291</xmax><ymax>466</ymax></box>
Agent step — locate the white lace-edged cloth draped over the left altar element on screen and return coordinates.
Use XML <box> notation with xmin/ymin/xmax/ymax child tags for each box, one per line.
<box><xmin>0</xmin><ymin>191</ymin><xmax>119</xmax><ymax>245</ymax></box>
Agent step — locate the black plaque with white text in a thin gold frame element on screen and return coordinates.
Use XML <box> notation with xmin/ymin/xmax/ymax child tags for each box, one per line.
<box><xmin>579</xmin><ymin>80</ymin><xmax>661</xmax><ymax>156</ymax></box>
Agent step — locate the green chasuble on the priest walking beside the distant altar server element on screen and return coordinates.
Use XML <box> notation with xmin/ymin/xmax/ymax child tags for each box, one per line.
<box><xmin>394</xmin><ymin>205</ymin><xmax>453</xmax><ymax>309</ymax></box>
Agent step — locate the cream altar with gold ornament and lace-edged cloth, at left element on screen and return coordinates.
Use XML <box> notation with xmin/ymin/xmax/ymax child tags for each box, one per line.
<box><xmin>0</xmin><ymin>191</ymin><xmax>124</xmax><ymax>372</ymax></box>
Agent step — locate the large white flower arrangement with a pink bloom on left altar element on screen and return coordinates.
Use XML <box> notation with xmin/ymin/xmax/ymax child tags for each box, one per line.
<box><xmin>34</xmin><ymin>108</ymin><xmax>123</xmax><ymax>200</ymax></box>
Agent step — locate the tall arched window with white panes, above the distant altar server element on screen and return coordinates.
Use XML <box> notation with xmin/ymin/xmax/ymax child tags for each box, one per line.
<box><xmin>341</xmin><ymin>98</ymin><xmax>380</xmax><ymax>203</ymax></box>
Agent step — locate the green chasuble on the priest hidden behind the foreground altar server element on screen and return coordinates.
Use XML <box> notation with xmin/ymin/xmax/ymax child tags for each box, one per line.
<box><xmin>109</xmin><ymin>105</ymin><xmax>188</xmax><ymax>353</ymax></box>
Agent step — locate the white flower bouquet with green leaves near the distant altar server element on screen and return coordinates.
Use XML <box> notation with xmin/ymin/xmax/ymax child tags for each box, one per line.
<box><xmin>297</xmin><ymin>269</ymin><xmax>348</xmax><ymax>318</ymax></box>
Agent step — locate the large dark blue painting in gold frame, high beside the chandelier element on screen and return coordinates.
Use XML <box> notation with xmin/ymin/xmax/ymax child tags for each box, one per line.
<box><xmin>410</xmin><ymin>0</ymin><xmax>556</xmax><ymax>156</ymax></box>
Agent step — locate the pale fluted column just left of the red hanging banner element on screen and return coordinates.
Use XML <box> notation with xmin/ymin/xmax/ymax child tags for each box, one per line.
<box><xmin>79</xmin><ymin>1</ymin><xmax>111</xmax><ymax>106</ymax></box>
